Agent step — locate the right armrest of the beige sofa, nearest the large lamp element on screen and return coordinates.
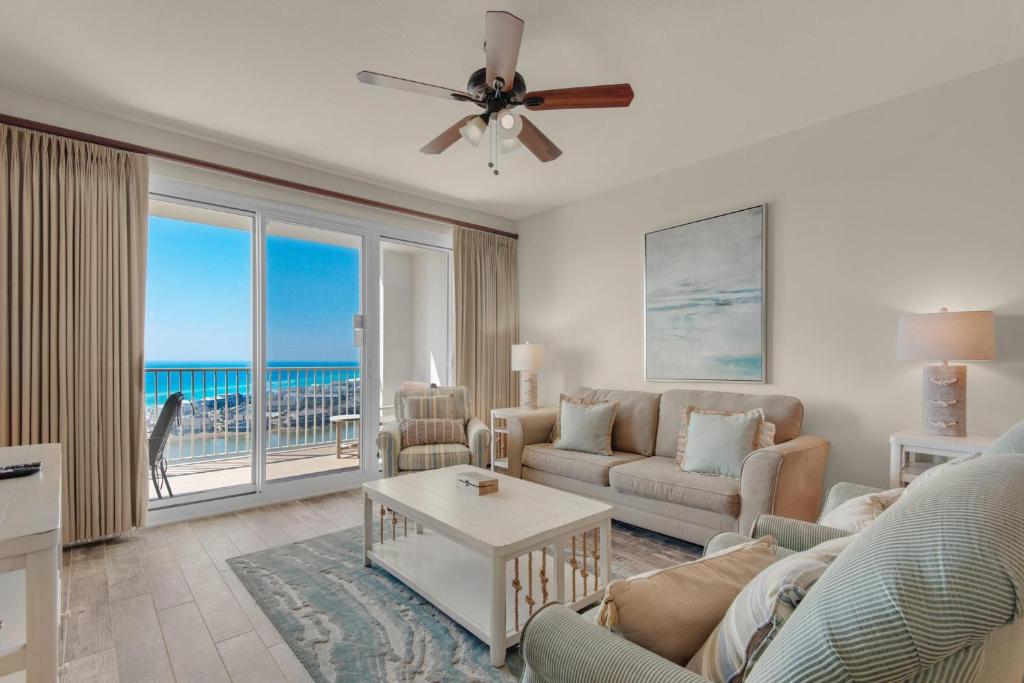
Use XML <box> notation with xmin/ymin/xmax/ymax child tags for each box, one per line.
<box><xmin>736</xmin><ymin>434</ymin><xmax>828</xmax><ymax>533</ymax></box>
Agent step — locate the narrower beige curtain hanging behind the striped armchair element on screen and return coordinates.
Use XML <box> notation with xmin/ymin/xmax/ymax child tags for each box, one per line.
<box><xmin>455</xmin><ymin>227</ymin><xmax>519</xmax><ymax>422</ymax></box>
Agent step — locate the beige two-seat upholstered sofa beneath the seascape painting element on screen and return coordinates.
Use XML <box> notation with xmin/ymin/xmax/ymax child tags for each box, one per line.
<box><xmin>507</xmin><ymin>387</ymin><xmax>828</xmax><ymax>545</ymax></box>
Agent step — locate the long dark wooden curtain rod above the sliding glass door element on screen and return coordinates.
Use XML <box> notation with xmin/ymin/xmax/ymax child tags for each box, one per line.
<box><xmin>0</xmin><ymin>114</ymin><xmax>519</xmax><ymax>240</ymax></box>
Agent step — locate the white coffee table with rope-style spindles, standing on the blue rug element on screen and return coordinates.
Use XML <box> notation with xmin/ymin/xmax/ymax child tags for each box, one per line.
<box><xmin>362</xmin><ymin>465</ymin><xmax>611</xmax><ymax>667</ymax></box>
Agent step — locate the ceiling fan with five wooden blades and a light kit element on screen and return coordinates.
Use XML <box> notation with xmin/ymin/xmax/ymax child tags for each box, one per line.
<box><xmin>355</xmin><ymin>11</ymin><xmax>633</xmax><ymax>175</ymax></box>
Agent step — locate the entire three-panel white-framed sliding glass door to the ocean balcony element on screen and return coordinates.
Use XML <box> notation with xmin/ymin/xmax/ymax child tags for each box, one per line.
<box><xmin>145</xmin><ymin>177</ymin><xmax>452</xmax><ymax>511</ymax></box>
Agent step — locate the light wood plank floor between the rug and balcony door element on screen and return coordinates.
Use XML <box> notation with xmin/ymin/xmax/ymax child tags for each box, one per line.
<box><xmin>61</xmin><ymin>489</ymin><xmax>362</xmax><ymax>683</ymax></box>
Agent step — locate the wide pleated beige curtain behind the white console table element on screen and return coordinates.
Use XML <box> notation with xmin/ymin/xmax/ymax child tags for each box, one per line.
<box><xmin>0</xmin><ymin>125</ymin><xmax>148</xmax><ymax>543</ymax></box>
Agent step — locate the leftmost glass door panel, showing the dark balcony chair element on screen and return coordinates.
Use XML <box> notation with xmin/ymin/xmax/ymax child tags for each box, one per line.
<box><xmin>145</xmin><ymin>200</ymin><xmax>256</xmax><ymax>501</ymax></box>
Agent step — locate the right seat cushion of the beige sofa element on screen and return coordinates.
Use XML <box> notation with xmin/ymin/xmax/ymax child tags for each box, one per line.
<box><xmin>609</xmin><ymin>458</ymin><xmax>739</xmax><ymax>517</ymax></box>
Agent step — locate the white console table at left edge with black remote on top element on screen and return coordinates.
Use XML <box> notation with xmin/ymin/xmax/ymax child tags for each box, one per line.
<box><xmin>0</xmin><ymin>443</ymin><xmax>60</xmax><ymax>683</ymax></box>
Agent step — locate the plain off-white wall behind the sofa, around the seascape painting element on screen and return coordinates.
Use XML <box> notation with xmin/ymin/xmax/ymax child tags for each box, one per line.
<box><xmin>516</xmin><ymin>57</ymin><xmax>1024</xmax><ymax>485</ymax></box>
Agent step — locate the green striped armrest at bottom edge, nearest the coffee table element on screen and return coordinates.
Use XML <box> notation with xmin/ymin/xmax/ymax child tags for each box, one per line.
<box><xmin>520</xmin><ymin>602</ymin><xmax>708</xmax><ymax>683</ymax></box>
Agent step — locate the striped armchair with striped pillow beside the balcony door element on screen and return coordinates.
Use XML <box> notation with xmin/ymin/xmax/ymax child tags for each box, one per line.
<box><xmin>377</xmin><ymin>387</ymin><xmax>490</xmax><ymax>477</ymax></box>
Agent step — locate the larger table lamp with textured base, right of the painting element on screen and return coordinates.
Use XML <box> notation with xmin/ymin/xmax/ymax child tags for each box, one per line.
<box><xmin>896</xmin><ymin>308</ymin><xmax>995</xmax><ymax>436</ymax></box>
